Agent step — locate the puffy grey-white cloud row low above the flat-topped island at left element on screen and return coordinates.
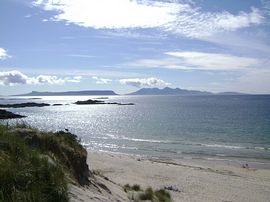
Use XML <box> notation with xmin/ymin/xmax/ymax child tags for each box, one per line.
<box><xmin>0</xmin><ymin>70</ymin><xmax>81</xmax><ymax>86</ymax></box>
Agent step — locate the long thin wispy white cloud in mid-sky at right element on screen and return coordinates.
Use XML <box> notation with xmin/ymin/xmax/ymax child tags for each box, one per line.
<box><xmin>127</xmin><ymin>52</ymin><xmax>260</xmax><ymax>71</ymax></box>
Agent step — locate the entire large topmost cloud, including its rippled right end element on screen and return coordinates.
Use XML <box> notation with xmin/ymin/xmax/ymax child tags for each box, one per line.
<box><xmin>33</xmin><ymin>0</ymin><xmax>264</xmax><ymax>38</ymax></box>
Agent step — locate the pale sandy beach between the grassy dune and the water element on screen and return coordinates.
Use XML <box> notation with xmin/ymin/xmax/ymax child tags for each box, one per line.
<box><xmin>69</xmin><ymin>151</ymin><xmax>270</xmax><ymax>202</ymax></box>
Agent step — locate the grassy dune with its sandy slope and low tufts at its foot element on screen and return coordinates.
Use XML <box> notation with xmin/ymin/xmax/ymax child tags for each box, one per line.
<box><xmin>0</xmin><ymin>125</ymin><xmax>171</xmax><ymax>202</ymax></box>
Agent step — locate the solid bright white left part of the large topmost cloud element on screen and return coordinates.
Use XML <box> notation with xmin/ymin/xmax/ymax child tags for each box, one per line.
<box><xmin>34</xmin><ymin>0</ymin><xmax>181</xmax><ymax>29</ymax></box>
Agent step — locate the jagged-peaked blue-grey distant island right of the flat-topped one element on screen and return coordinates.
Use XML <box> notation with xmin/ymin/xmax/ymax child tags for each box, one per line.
<box><xmin>128</xmin><ymin>87</ymin><xmax>213</xmax><ymax>95</ymax></box>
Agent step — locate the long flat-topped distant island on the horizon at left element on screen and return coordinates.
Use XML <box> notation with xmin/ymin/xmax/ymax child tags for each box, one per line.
<box><xmin>14</xmin><ymin>90</ymin><xmax>117</xmax><ymax>96</ymax></box>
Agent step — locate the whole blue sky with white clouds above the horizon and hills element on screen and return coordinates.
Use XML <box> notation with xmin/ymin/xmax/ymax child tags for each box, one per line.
<box><xmin>0</xmin><ymin>0</ymin><xmax>270</xmax><ymax>95</ymax></box>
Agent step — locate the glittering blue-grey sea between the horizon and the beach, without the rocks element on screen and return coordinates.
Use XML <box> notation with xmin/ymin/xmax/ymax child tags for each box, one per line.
<box><xmin>0</xmin><ymin>95</ymin><xmax>270</xmax><ymax>162</ymax></box>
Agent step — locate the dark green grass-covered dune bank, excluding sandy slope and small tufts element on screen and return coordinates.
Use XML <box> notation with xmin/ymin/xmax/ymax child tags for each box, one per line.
<box><xmin>0</xmin><ymin>125</ymin><xmax>90</xmax><ymax>202</ymax></box>
